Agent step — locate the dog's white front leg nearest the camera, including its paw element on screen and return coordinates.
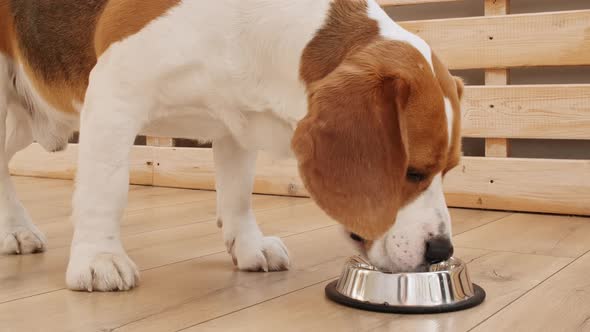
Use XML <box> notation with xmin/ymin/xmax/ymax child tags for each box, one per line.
<box><xmin>66</xmin><ymin>72</ymin><xmax>149</xmax><ymax>291</ymax></box>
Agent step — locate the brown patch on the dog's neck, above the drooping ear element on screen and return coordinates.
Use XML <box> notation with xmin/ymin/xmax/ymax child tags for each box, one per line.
<box><xmin>300</xmin><ymin>0</ymin><xmax>379</xmax><ymax>84</ymax></box>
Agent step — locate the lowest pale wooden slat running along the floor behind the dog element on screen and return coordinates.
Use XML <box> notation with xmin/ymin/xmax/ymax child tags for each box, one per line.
<box><xmin>11</xmin><ymin>145</ymin><xmax>590</xmax><ymax>215</ymax></box>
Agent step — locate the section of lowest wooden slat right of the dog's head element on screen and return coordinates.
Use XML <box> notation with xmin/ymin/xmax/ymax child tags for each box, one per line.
<box><xmin>445</xmin><ymin>157</ymin><xmax>590</xmax><ymax>215</ymax></box>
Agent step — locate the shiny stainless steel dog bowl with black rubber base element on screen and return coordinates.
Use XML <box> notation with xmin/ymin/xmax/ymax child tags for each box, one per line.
<box><xmin>326</xmin><ymin>256</ymin><xmax>485</xmax><ymax>314</ymax></box>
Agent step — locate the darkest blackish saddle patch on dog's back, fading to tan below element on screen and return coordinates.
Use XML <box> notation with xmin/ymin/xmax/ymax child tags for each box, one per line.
<box><xmin>10</xmin><ymin>0</ymin><xmax>107</xmax><ymax>112</ymax></box>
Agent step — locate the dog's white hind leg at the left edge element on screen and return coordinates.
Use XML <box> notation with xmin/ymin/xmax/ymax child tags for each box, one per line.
<box><xmin>0</xmin><ymin>57</ymin><xmax>47</xmax><ymax>255</ymax></box>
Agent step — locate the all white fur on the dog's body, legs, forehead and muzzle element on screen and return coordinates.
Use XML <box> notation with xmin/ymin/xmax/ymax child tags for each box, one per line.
<box><xmin>0</xmin><ymin>0</ymin><xmax>450</xmax><ymax>291</ymax></box>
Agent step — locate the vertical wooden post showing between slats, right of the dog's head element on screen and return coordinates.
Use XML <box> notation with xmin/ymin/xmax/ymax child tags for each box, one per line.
<box><xmin>484</xmin><ymin>0</ymin><xmax>510</xmax><ymax>158</ymax></box>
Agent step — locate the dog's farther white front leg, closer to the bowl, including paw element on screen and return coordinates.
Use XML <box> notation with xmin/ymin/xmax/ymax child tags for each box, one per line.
<box><xmin>213</xmin><ymin>137</ymin><xmax>289</xmax><ymax>271</ymax></box>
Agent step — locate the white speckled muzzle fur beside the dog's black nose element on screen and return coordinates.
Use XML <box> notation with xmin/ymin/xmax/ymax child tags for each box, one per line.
<box><xmin>367</xmin><ymin>174</ymin><xmax>451</xmax><ymax>272</ymax></box>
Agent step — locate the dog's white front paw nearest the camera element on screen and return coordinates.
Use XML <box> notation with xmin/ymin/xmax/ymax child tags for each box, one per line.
<box><xmin>66</xmin><ymin>245</ymin><xmax>139</xmax><ymax>292</ymax></box>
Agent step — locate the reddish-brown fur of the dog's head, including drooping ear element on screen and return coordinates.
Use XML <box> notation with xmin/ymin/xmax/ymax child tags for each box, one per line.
<box><xmin>292</xmin><ymin>40</ymin><xmax>448</xmax><ymax>240</ymax></box>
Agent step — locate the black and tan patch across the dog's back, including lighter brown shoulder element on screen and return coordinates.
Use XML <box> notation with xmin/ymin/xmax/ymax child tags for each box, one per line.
<box><xmin>5</xmin><ymin>0</ymin><xmax>180</xmax><ymax>113</ymax></box>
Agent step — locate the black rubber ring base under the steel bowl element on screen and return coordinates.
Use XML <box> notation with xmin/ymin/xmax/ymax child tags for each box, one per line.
<box><xmin>326</xmin><ymin>280</ymin><xmax>486</xmax><ymax>315</ymax></box>
